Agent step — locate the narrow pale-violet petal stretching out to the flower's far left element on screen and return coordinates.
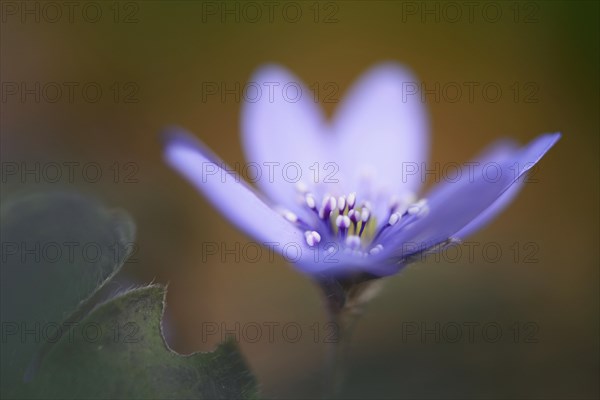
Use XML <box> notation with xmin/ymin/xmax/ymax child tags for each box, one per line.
<box><xmin>165</xmin><ymin>130</ymin><xmax>312</xmax><ymax>260</ymax></box>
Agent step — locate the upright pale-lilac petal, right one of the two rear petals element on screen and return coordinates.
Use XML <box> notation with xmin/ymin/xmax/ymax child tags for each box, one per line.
<box><xmin>333</xmin><ymin>62</ymin><xmax>429</xmax><ymax>198</ymax></box>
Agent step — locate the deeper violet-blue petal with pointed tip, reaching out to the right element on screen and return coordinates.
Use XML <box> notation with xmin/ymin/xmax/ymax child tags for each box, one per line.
<box><xmin>384</xmin><ymin>133</ymin><xmax>560</xmax><ymax>256</ymax></box>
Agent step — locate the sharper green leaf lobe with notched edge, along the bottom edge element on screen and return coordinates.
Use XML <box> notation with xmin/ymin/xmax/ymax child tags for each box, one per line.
<box><xmin>24</xmin><ymin>286</ymin><xmax>257</xmax><ymax>399</ymax></box>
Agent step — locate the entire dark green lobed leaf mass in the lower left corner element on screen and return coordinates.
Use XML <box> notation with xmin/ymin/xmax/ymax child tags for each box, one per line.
<box><xmin>0</xmin><ymin>192</ymin><xmax>257</xmax><ymax>399</ymax></box>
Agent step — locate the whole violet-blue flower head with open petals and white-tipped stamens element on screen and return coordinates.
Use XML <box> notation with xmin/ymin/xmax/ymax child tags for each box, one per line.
<box><xmin>165</xmin><ymin>63</ymin><xmax>560</xmax><ymax>279</ymax></box>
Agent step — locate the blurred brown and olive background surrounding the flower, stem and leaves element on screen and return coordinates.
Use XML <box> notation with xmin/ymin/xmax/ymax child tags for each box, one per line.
<box><xmin>0</xmin><ymin>1</ymin><xmax>600</xmax><ymax>399</ymax></box>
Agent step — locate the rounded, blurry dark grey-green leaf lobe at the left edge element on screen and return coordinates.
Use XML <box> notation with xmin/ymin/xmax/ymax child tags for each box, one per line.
<box><xmin>0</xmin><ymin>192</ymin><xmax>135</xmax><ymax>397</ymax></box>
